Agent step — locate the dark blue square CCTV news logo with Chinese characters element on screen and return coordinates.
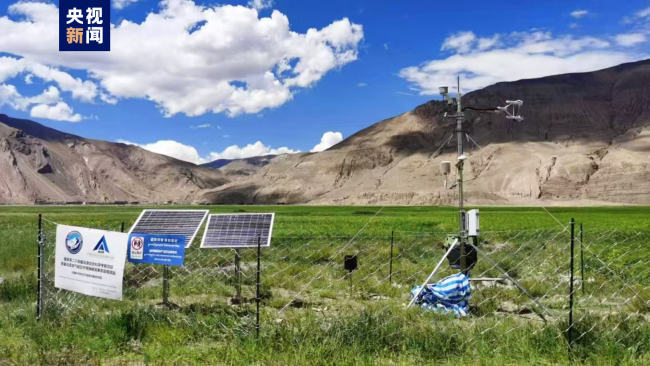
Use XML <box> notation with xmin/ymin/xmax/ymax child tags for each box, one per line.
<box><xmin>59</xmin><ymin>0</ymin><xmax>111</xmax><ymax>51</ymax></box>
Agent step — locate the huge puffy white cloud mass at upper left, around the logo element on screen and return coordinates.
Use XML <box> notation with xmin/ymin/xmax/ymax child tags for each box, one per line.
<box><xmin>0</xmin><ymin>0</ymin><xmax>363</xmax><ymax>116</ymax></box>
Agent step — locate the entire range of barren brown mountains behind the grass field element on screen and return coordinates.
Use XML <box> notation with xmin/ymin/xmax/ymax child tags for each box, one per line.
<box><xmin>0</xmin><ymin>60</ymin><xmax>650</xmax><ymax>205</ymax></box>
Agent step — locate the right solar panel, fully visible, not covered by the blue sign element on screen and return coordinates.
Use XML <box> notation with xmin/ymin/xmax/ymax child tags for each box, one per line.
<box><xmin>201</xmin><ymin>213</ymin><xmax>275</xmax><ymax>248</ymax></box>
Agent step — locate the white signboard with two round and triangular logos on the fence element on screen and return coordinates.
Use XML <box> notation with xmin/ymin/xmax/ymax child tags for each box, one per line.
<box><xmin>54</xmin><ymin>225</ymin><xmax>129</xmax><ymax>300</ymax></box>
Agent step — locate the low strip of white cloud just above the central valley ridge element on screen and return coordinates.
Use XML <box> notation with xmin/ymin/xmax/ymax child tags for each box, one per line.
<box><xmin>117</xmin><ymin>140</ymin><xmax>300</xmax><ymax>164</ymax></box>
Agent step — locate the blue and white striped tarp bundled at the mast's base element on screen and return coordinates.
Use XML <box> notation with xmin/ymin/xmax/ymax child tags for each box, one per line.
<box><xmin>411</xmin><ymin>273</ymin><xmax>471</xmax><ymax>316</ymax></box>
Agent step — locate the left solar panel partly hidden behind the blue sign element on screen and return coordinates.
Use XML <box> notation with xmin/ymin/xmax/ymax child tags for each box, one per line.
<box><xmin>129</xmin><ymin>210</ymin><xmax>209</xmax><ymax>248</ymax></box>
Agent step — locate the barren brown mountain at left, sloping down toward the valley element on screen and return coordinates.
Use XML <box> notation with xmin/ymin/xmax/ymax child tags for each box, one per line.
<box><xmin>0</xmin><ymin>114</ymin><xmax>228</xmax><ymax>203</ymax></box>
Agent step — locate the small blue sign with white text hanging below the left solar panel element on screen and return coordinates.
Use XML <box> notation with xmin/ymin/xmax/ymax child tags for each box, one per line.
<box><xmin>128</xmin><ymin>233</ymin><xmax>185</xmax><ymax>267</ymax></box>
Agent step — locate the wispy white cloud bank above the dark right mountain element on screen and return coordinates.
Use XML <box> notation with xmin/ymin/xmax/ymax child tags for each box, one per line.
<box><xmin>399</xmin><ymin>31</ymin><xmax>648</xmax><ymax>95</ymax></box>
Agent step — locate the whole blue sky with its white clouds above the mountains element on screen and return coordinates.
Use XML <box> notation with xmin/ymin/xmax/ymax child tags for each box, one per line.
<box><xmin>0</xmin><ymin>0</ymin><xmax>650</xmax><ymax>162</ymax></box>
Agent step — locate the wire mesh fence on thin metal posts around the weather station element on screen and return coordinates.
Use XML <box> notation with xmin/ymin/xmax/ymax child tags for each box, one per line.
<box><xmin>37</xmin><ymin>216</ymin><xmax>650</xmax><ymax>358</ymax></box>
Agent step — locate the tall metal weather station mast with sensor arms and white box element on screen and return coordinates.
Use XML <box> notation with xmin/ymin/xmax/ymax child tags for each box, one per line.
<box><xmin>438</xmin><ymin>76</ymin><xmax>524</xmax><ymax>274</ymax></box>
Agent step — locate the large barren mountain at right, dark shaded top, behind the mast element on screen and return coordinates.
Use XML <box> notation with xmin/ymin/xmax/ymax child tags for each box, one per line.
<box><xmin>196</xmin><ymin>60</ymin><xmax>650</xmax><ymax>205</ymax></box>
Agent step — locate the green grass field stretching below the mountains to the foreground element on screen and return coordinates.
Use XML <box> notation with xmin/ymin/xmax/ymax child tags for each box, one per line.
<box><xmin>0</xmin><ymin>206</ymin><xmax>650</xmax><ymax>365</ymax></box>
